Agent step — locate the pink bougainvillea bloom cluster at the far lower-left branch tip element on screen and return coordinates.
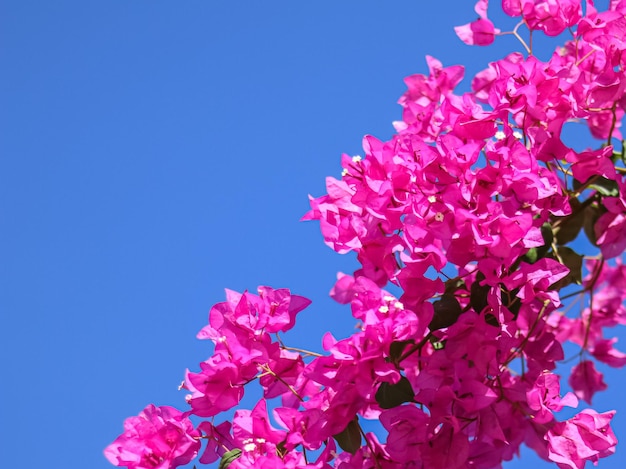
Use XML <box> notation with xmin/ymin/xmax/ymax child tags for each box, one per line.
<box><xmin>104</xmin><ymin>404</ymin><xmax>200</xmax><ymax>469</ymax></box>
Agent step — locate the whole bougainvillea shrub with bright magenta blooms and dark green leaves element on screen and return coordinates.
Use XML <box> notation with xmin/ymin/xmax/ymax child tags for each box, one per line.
<box><xmin>105</xmin><ymin>0</ymin><xmax>626</xmax><ymax>469</ymax></box>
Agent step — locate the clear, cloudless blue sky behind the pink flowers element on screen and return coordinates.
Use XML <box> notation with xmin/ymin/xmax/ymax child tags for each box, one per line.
<box><xmin>0</xmin><ymin>0</ymin><xmax>626</xmax><ymax>469</ymax></box>
